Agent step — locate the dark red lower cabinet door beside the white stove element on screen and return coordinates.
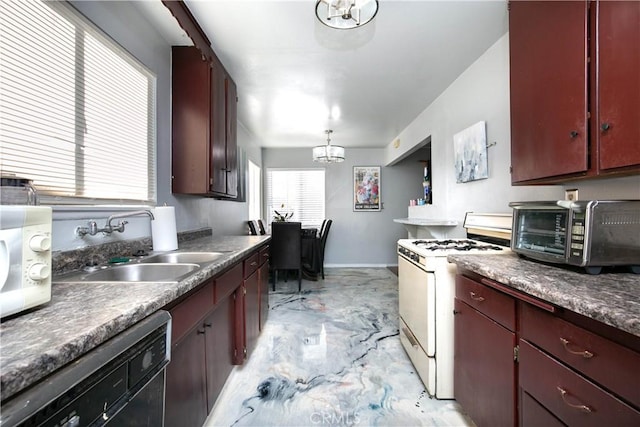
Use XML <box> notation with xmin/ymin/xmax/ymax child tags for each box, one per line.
<box><xmin>454</xmin><ymin>298</ymin><xmax>516</xmax><ymax>427</ymax></box>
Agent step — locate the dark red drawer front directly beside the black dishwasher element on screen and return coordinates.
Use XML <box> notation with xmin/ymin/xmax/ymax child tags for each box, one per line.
<box><xmin>169</xmin><ymin>282</ymin><xmax>213</xmax><ymax>345</ymax></box>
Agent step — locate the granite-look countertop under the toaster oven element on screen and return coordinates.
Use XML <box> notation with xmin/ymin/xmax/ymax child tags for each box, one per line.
<box><xmin>447</xmin><ymin>253</ymin><xmax>640</xmax><ymax>337</ymax></box>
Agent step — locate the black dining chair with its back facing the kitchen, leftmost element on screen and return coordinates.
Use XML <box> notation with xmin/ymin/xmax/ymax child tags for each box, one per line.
<box><xmin>269</xmin><ymin>221</ymin><xmax>302</xmax><ymax>292</ymax></box>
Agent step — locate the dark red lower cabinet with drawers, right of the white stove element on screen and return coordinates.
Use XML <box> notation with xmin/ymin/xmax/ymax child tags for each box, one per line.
<box><xmin>454</xmin><ymin>273</ymin><xmax>640</xmax><ymax>427</ymax></box>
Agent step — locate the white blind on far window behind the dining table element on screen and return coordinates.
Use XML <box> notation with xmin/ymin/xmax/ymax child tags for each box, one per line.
<box><xmin>267</xmin><ymin>169</ymin><xmax>325</xmax><ymax>229</ymax></box>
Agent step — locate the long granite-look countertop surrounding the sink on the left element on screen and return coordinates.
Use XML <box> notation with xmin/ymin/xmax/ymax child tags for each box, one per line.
<box><xmin>0</xmin><ymin>235</ymin><xmax>271</xmax><ymax>400</ymax></box>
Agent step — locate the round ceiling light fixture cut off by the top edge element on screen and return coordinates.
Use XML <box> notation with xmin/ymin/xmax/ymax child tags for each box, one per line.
<box><xmin>316</xmin><ymin>0</ymin><xmax>378</xmax><ymax>30</ymax></box>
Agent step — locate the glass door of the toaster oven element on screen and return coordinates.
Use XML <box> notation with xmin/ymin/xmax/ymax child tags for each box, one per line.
<box><xmin>511</xmin><ymin>206</ymin><xmax>571</xmax><ymax>263</ymax></box>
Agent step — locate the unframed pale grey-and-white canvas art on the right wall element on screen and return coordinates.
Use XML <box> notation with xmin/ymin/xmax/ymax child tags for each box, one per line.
<box><xmin>453</xmin><ymin>122</ymin><xmax>489</xmax><ymax>183</ymax></box>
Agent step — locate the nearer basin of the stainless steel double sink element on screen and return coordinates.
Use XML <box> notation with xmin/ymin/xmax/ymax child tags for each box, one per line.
<box><xmin>58</xmin><ymin>264</ymin><xmax>200</xmax><ymax>283</ymax></box>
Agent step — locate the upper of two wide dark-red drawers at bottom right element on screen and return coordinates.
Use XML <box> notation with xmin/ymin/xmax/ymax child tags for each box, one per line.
<box><xmin>520</xmin><ymin>304</ymin><xmax>640</xmax><ymax>407</ymax></box>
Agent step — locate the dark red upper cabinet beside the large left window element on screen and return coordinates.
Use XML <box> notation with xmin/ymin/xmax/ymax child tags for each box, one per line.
<box><xmin>171</xmin><ymin>46</ymin><xmax>238</xmax><ymax>198</ymax></box>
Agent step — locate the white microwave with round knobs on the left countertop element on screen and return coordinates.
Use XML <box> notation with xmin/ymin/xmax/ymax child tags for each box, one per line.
<box><xmin>0</xmin><ymin>205</ymin><xmax>51</xmax><ymax>317</ymax></box>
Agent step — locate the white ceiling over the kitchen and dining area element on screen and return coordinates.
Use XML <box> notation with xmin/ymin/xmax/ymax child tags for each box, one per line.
<box><xmin>134</xmin><ymin>0</ymin><xmax>508</xmax><ymax>147</ymax></box>
